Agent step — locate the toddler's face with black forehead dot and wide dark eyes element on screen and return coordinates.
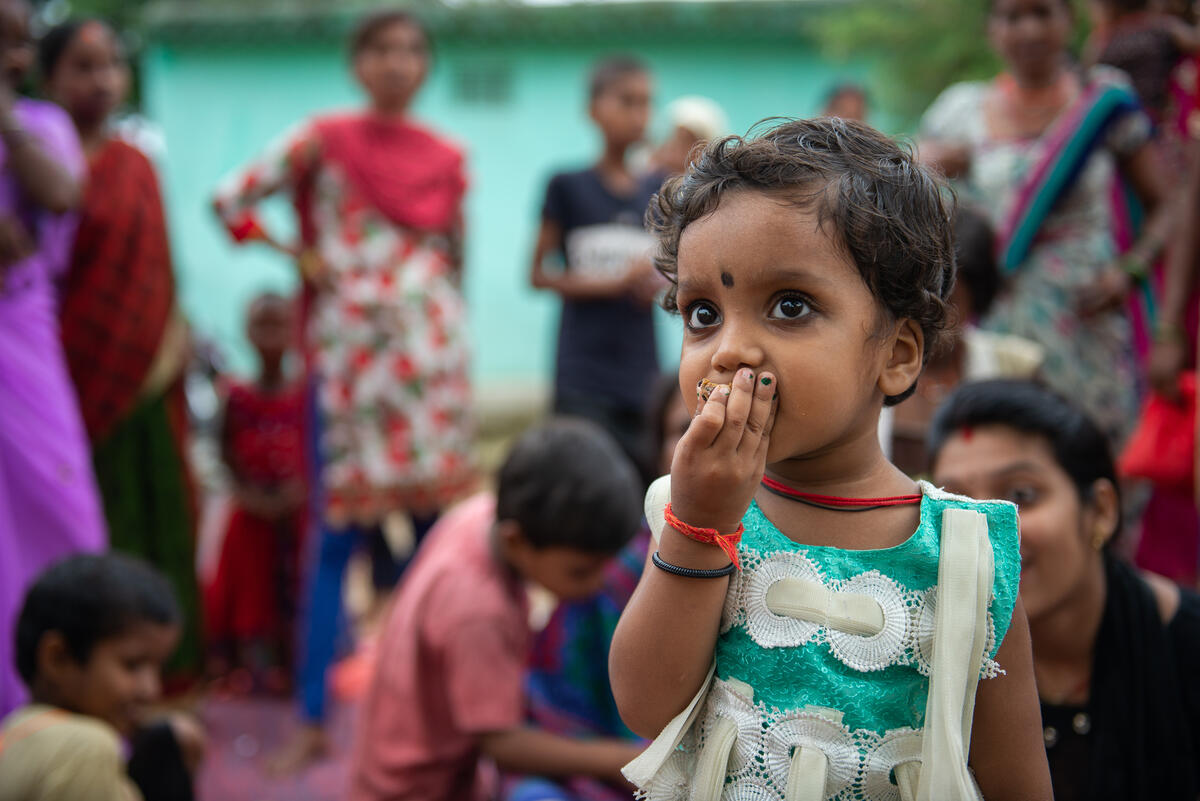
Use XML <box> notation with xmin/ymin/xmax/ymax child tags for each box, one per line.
<box><xmin>677</xmin><ymin>191</ymin><xmax>914</xmax><ymax>464</ymax></box>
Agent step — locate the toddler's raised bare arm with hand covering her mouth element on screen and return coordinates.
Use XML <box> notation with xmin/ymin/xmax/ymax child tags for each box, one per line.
<box><xmin>608</xmin><ymin>371</ymin><xmax>775</xmax><ymax>737</ymax></box>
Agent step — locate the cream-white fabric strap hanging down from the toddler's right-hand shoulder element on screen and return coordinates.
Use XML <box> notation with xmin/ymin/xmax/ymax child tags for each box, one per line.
<box><xmin>917</xmin><ymin>508</ymin><xmax>995</xmax><ymax>801</ymax></box>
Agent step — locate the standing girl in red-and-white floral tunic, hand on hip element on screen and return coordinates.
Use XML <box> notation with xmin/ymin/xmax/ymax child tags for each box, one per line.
<box><xmin>215</xmin><ymin>4</ymin><xmax>474</xmax><ymax>770</ymax></box>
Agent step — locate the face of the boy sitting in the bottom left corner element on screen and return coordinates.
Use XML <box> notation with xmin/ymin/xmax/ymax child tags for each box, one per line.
<box><xmin>46</xmin><ymin>622</ymin><xmax>180</xmax><ymax>735</ymax></box>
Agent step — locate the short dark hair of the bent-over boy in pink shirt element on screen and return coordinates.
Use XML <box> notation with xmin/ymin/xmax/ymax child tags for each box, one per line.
<box><xmin>496</xmin><ymin>418</ymin><xmax>642</xmax><ymax>554</ymax></box>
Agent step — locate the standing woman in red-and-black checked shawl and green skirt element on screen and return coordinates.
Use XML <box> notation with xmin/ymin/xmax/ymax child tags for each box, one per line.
<box><xmin>38</xmin><ymin>20</ymin><xmax>200</xmax><ymax>674</ymax></box>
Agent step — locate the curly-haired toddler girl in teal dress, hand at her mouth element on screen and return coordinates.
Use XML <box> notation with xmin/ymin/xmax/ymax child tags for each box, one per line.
<box><xmin>610</xmin><ymin>119</ymin><xmax>1051</xmax><ymax>801</ymax></box>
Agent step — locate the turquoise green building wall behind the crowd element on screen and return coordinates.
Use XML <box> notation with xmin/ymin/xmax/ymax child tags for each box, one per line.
<box><xmin>142</xmin><ymin>35</ymin><xmax>886</xmax><ymax>387</ymax></box>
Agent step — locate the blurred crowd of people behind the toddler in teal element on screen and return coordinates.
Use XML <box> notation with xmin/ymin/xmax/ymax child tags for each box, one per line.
<box><xmin>0</xmin><ymin>0</ymin><xmax>1200</xmax><ymax>801</ymax></box>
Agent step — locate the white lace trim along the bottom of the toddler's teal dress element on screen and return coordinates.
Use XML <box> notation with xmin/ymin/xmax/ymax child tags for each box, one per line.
<box><xmin>637</xmin><ymin>680</ymin><xmax>940</xmax><ymax>801</ymax></box>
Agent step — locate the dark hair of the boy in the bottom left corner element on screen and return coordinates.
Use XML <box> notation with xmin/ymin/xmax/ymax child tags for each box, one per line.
<box><xmin>14</xmin><ymin>553</ymin><xmax>181</xmax><ymax>687</ymax></box>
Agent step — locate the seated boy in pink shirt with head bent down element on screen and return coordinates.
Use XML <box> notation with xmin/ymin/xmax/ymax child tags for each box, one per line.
<box><xmin>349</xmin><ymin>420</ymin><xmax>641</xmax><ymax>801</ymax></box>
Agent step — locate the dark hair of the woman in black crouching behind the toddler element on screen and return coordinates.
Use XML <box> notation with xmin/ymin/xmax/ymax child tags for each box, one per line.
<box><xmin>925</xmin><ymin>379</ymin><xmax>1121</xmax><ymax>532</ymax></box>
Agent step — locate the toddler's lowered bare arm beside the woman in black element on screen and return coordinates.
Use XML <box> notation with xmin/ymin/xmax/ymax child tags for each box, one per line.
<box><xmin>968</xmin><ymin>598</ymin><xmax>1054</xmax><ymax>801</ymax></box>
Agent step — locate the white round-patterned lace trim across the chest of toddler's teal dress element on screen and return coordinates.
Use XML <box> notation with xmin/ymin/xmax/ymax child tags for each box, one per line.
<box><xmin>721</xmin><ymin>547</ymin><xmax>1004</xmax><ymax>679</ymax></box>
